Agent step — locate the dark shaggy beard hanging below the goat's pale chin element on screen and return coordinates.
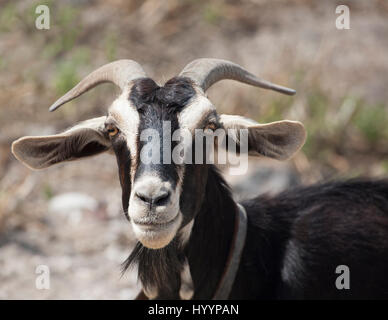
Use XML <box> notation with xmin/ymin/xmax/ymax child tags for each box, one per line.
<box><xmin>122</xmin><ymin>238</ymin><xmax>185</xmax><ymax>299</ymax></box>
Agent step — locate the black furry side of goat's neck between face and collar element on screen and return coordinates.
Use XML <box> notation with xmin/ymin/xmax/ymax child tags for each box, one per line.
<box><xmin>185</xmin><ymin>166</ymin><xmax>236</xmax><ymax>299</ymax></box>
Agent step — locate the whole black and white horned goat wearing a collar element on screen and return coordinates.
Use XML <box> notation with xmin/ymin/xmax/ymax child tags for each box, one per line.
<box><xmin>12</xmin><ymin>59</ymin><xmax>388</xmax><ymax>299</ymax></box>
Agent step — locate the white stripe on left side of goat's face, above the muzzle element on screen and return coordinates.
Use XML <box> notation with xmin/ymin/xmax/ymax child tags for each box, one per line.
<box><xmin>109</xmin><ymin>91</ymin><xmax>140</xmax><ymax>179</ymax></box>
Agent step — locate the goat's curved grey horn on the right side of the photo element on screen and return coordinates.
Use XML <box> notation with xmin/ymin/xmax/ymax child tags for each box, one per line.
<box><xmin>179</xmin><ymin>59</ymin><xmax>296</xmax><ymax>95</ymax></box>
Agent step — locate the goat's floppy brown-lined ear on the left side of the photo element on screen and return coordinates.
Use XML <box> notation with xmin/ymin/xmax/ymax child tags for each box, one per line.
<box><xmin>12</xmin><ymin>117</ymin><xmax>111</xmax><ymax>169</ymax></box>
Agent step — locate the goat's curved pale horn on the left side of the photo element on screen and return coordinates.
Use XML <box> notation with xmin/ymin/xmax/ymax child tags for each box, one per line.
<box><xmin>49</xmin><ymin>59</ymin><xmax>146</xmax><ymax>111</ymax></box>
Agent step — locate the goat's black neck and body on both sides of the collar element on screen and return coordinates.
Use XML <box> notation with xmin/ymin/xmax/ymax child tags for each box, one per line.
<box><xmin>187</xmin><ymin>171</ymin><xmax>388</xmax><ymax>299</ymax></box>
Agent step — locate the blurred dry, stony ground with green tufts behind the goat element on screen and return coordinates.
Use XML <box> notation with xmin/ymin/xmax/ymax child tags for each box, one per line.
<box><xmin>0</xmin><ymin>0</ymin><xmax>388</xmax><ymax>299</ymax></box>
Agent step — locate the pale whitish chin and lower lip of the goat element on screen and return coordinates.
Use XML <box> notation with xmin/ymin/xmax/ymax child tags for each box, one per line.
<box><xmin>131</xmin><ymin>212</ymin><xmax>182</xmax><ymax>249</ymax></box>
